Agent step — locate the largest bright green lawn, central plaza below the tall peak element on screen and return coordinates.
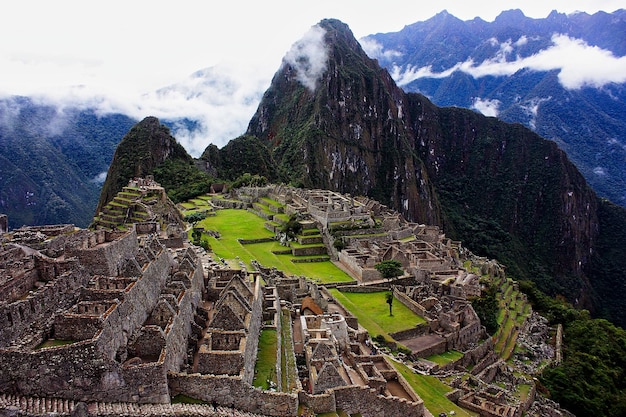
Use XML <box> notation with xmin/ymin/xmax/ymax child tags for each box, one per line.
<box><xmin>199</xmin><ymin>209</ymin><xmax>354</xmax><ymax>283</ymax></box>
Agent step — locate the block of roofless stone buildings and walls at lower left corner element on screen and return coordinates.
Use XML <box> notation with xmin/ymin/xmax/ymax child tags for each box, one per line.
<box><xmin>0</xmin><ymin>224</ymin><xmax>203</xmax><ymax>403</ymax></box>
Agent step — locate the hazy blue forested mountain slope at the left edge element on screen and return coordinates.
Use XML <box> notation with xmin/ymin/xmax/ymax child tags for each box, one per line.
<box><xmin>0</xmin><ymin>97</ymin><xmax>135</xmax><ymax>228</ymax></box>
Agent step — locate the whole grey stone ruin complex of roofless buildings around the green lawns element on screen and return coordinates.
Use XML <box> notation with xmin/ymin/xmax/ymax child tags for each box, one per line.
<box><xmin>0</xmin><ymin>179</ymin><xmax>560</xmax><ymax>417</ymax></box>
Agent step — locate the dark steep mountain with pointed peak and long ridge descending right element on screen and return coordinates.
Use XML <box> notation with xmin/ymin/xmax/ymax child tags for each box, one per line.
<box><xmin>247</xmin><ymin>20</ymin><xmax>621</xmax><ymax>322</ymax></box>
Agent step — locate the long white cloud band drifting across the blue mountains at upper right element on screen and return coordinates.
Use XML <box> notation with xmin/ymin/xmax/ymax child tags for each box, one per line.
<box><xmin>391</xmin><ymin>34</ymin><xmax>626</xmax><ymax>90</ymax></box>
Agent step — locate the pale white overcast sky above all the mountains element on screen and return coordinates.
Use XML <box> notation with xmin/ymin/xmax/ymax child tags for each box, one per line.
<box><xmin>0</xmin><ymin>0</ymin><xmax>626</xmax><ymax>156</ymax></box>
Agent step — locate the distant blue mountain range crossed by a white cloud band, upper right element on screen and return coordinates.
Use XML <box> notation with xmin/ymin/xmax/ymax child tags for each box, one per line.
<box><xmin>361</xmin><ymin>9</ymin><xmax>626</xmax><ymax>206</ymax></box>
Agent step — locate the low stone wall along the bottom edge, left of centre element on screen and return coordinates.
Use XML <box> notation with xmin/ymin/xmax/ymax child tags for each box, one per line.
<box><xmin>168</xmin><ymin>373</ymin><xmax>298</xmax><ymax>417</ymax></box>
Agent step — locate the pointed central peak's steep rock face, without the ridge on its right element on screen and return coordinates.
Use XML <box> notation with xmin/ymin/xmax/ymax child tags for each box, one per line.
<box><xmin>247</xmin><ymin>20</ymin><xmax>441</xmax><ymax>224</ymax></box>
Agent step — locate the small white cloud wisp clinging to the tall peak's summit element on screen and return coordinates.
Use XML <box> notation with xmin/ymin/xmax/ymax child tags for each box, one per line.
<box><xmin>283</xmin><ymin>25</ymin><xmax>328</xmax><ymax>91</ymax></box>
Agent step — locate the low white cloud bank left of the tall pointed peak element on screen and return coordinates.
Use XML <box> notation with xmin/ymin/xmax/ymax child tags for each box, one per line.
<box><xmin>0</xmin><ymin>64</ymin><xmax>271</xmax><ymax>157</ymax></box>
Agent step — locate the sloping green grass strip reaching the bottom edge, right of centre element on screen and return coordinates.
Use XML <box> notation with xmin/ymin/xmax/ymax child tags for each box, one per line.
<box><xmin>391</xmin><ymin>361</ymin><xmax>478</xmax><ymax>417</ymax></box>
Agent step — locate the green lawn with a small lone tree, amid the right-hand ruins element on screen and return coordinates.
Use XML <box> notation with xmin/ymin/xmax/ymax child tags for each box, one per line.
<box><xmin>330</xmin><ymin>289</ymin><xmax>426</xmax><ymax>338</ymax></box>
